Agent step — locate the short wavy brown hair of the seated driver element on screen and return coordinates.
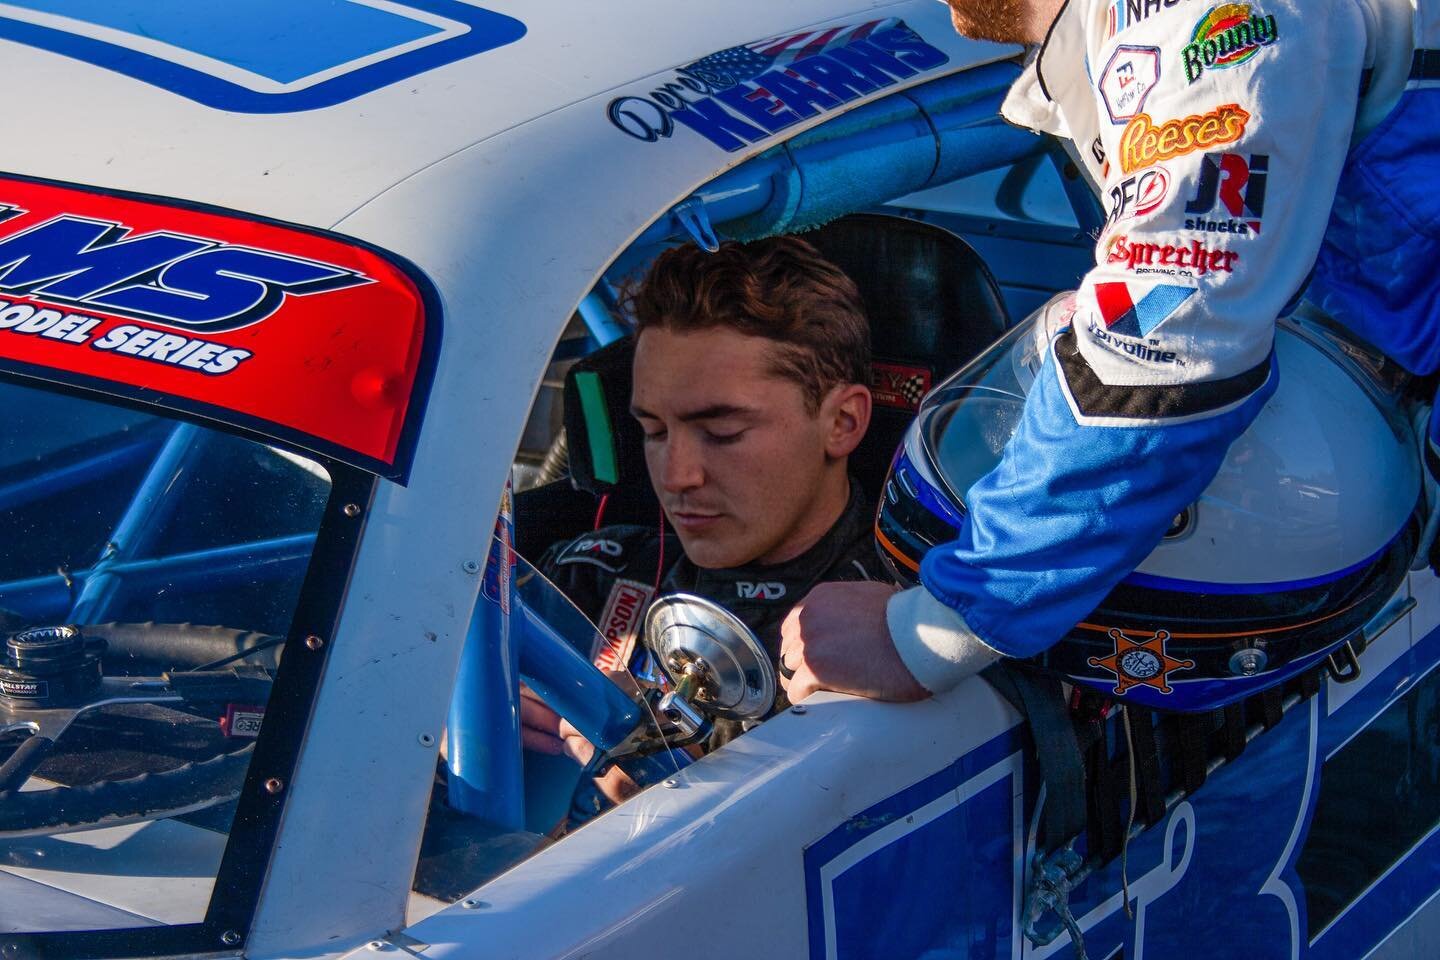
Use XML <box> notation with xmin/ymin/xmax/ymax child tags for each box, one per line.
<box><xmin>624</xmin><ymin>236</ymin><xmax>870</xmax><ymax>412</ymax></box>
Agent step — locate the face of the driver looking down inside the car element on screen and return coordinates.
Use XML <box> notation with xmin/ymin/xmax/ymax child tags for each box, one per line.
<box><xmin>631</xmin><ymin>328</ymin><xmax>844</xmax><ymax>570</ymax></box>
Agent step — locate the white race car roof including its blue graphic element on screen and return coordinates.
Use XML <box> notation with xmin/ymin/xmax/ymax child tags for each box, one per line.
<box><xmin>0</xmin><ymin>0</ymin><xmax>967</xmax><ymax>227</ymax></box>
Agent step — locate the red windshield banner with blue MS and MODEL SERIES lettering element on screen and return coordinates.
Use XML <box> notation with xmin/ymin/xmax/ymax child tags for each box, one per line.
<box><xmin>0</xmin><ymin>177</ymin><xmax>439</xmax><ymax>479</ymax></box>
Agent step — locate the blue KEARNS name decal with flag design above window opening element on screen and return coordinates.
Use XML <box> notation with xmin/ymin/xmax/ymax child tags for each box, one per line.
<box><xmin>606</xmin><ymin>17</ymin><xmax>950</xmax><ymax>151</ymax></box>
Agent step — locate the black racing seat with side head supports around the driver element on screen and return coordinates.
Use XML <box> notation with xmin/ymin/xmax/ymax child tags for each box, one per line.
<box><xmin>516</xmin><ymin>213</ymin><xmax>1009</xmax><ymax>558</ymax></box>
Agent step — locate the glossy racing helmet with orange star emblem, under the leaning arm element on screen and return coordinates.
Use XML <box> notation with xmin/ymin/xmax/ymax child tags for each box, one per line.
<box><xmin>876</xmin><ymin>298</ymin><xmax>1423</xmax><ymax>711</ymax></box>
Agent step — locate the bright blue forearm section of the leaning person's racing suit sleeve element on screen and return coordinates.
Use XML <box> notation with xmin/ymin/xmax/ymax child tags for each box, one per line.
<box><xmin>920</xmin><ymin>332</ymin><xmax>1276</xmax><ymax>656</ymax></box>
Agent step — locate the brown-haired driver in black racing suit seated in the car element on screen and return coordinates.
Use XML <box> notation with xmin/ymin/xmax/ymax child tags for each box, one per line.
<box><xmin>521</xmin><ymin>236</ymin><xmax>884</xmax><ymax>800</ymax></box>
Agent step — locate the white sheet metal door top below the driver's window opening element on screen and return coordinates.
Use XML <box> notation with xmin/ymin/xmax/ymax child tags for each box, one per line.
<box><xmin>394</xmin><ymin>678</ymin><xmax>1021</xmax><ymax>960</ymax></box>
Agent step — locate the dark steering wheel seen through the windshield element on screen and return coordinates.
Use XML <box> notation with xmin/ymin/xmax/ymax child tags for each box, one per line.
<box><xmin>0</xmin><ymin>623</ymin><xmax>282</xmax><ymax>838</ymax></box>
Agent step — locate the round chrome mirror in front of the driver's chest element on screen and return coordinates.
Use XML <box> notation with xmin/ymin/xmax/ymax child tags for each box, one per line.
<box><xmin>645</xmin><ymin>593</ymin><xmax>776</xmax><ymax>720</ymax></box>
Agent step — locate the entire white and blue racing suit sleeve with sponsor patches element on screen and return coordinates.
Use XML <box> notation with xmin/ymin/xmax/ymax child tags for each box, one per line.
<box><xmin>891</xmin><ymin>0</ymin><xmax>1365</xmax><ymax>673</ymax></box>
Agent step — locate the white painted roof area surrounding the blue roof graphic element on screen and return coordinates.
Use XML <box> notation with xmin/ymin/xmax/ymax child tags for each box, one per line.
<box><xmin>0</xmin><ymin>0</ymin><xmax>1002</xmax><ymax>227</ymax></box>
